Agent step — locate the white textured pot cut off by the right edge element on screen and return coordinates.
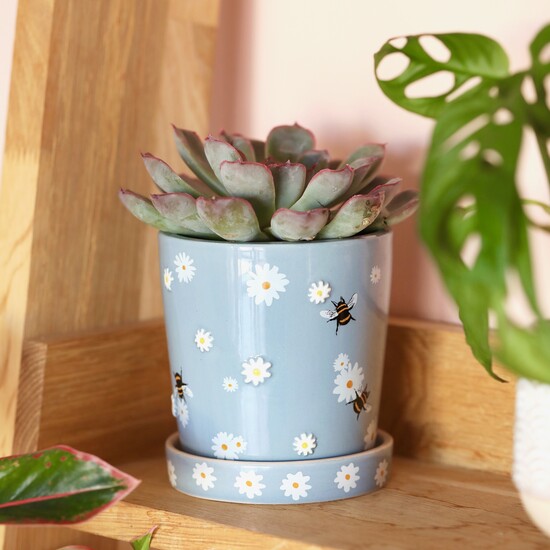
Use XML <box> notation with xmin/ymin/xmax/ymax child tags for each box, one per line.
<box><xmin>513</xmin><ymin>379</ymin><xmax>550</xmax><ymax>536</ymax></box>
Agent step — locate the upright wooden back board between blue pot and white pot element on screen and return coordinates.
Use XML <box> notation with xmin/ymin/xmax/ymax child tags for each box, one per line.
<box><xmin>380</xmin><ymin>319</ymin><xmax>515</xmax><ymax>472</ymax></box>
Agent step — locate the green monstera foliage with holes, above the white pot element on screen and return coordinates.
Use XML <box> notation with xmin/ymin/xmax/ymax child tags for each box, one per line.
<box><xmin>375</xmin><ymin>25</ymin><xmax>550</xmax><ymax>383</ymax></box>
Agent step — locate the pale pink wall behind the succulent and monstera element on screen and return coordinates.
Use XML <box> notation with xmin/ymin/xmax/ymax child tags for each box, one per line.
<box><xmin>212</xmin><ymin>0</ymin><xmax>550</xmax><ymax>322</ymax></box>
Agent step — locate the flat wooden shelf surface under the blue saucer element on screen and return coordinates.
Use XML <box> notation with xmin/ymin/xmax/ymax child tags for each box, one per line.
<box><xmin>77</xmin><ymin>456</ymin><xmax>548</xmax><ymax>550</ymax></box>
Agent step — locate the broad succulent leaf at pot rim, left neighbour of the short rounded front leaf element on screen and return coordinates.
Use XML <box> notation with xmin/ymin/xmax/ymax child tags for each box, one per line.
<box><xmin>196</xmin><ymin>197</ymin><xmax>267</xmax><ymax>242</ymax></box>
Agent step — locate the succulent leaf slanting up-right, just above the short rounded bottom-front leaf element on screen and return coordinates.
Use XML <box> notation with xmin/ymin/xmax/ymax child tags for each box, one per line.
<box><xmin>292</xmin><ymin>166</ymin><xmax>354</xmax><ymax>212</ymax></box>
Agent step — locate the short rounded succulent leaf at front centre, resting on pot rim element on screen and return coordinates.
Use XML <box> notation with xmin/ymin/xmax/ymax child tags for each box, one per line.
<box><xmin>271</xmin><ymin>208</ymin><xmax>329</xmax><ymax>241</ymax></box>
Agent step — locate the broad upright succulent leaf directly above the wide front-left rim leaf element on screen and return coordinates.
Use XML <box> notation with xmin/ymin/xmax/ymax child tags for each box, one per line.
<box><xmin>220</xmin><ymin>161</ymin><xmax>275</xmax><ymax>227</ymax></box>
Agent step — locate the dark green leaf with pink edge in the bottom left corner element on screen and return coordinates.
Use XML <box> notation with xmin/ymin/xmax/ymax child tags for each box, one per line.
<box><xmin>0</xmin><ymin>445</ymin><xmax>139</xmax><ymax>524</ymax></box>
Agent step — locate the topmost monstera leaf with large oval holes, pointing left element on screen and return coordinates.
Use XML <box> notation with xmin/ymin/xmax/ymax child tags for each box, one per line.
<box><xmin>374</xmin><ymin>33</ymin><xmax>508</xmax><ymax>117</ymax></box>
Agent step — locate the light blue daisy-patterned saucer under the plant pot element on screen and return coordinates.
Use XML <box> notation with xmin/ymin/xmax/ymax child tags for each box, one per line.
<box><xmin>166</xmin><ymin>431</ymin><xmax>393</xmax><ymax>504</ymax></box>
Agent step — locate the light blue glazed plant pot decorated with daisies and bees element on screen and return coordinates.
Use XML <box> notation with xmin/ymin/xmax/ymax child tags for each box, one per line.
<box><xmin>159</xmin><ymin>233</ymin><xmax>392</xmax><ymax>461</ymax></box>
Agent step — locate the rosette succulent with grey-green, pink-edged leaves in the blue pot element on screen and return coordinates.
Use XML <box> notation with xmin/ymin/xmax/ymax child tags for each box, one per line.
<box><xmin>120</xmin><ymin>124</ymin><xmax>418</xmax><ymax>242</ymax></box>
